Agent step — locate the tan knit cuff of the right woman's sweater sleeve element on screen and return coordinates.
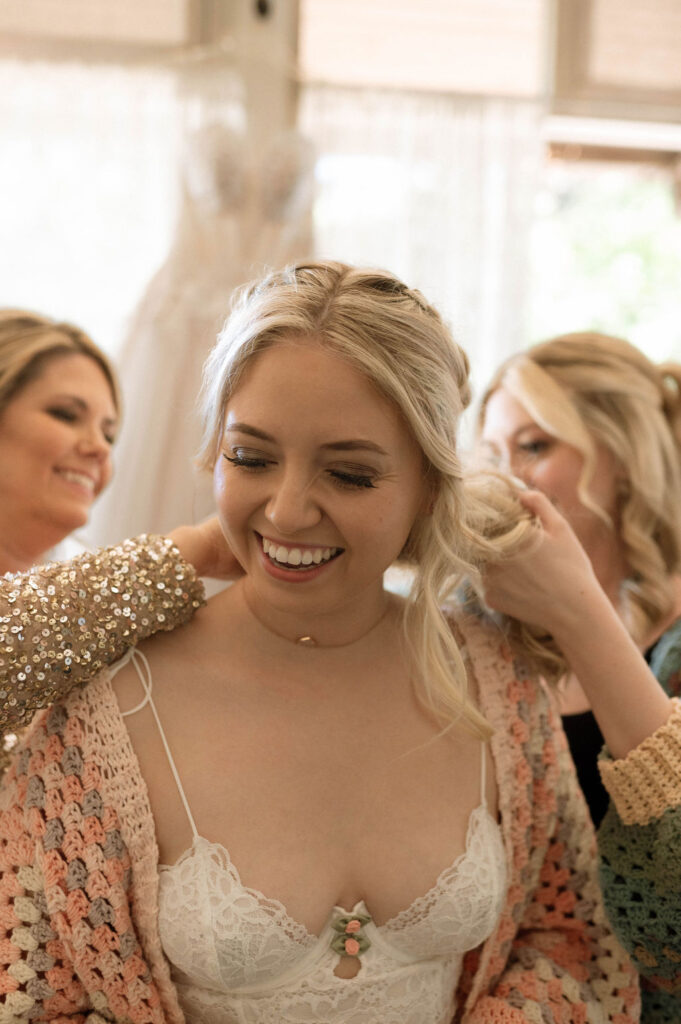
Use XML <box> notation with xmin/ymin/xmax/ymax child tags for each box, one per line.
<box><xmin>599</xmin><ymin>697</ymin><xmax>681</xmax><ymax>825</ymax></box>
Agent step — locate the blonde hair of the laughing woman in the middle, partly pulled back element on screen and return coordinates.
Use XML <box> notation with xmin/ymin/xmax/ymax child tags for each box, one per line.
<box><xmin>199</xmin><ymin>261</ymin><xmax>557</xmax><ymax>736</ymax></box>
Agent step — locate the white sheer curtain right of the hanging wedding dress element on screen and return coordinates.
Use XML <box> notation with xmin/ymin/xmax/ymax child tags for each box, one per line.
<box><xmin>300</xmin><ymin>85</ymin><xmax>542</xmax><ymax>397</ymax></box>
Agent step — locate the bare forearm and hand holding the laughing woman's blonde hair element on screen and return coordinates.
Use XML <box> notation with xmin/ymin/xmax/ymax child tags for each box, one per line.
<box><xmin>484</xmin><ymin>492</ymin><xmax>672</xmax><ymax>758</ymax></box>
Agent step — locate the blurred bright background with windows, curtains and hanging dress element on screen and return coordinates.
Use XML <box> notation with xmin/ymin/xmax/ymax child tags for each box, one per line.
<box><xmin>0</xmin><ymin>0</ymin><xmax>681</xmax><ymax>542</ymax></box>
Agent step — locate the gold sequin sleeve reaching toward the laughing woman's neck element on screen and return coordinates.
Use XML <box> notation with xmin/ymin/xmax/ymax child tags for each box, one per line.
<box><xmin>0</xmin><ymin>535</ymin><xmax>204</xmax><ymax>733</ymax></box>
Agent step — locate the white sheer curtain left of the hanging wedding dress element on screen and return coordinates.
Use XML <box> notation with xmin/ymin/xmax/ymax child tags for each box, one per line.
<box><xmin>0</xmin><ymin>59</ymin><xmax>181</xmax><ymax>354</ymax></box>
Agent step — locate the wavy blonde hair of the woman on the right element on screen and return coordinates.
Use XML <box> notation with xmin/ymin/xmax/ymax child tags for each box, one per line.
<box><xmin>478</xmin><ymin>332</ymin><xmax>681</xmax><ymax>641</ymax></box>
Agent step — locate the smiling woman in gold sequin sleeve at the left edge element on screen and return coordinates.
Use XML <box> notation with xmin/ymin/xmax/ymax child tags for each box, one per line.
<box><xmin>0</xmin><ymin>309</ymin><xmax>218</xmax><ymax>732</ymax></box>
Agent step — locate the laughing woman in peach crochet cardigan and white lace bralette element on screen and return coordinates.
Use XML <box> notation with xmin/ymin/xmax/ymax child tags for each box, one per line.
<box><xmin>0</xmin><ymin>262</ymin><xmax>638</xmax><ymax>1024</ymax></box>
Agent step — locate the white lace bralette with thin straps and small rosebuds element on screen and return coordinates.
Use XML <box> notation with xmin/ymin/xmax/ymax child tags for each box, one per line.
<box><xmin>116</xmin><ymin>652</ymin><xmax>506</xmax><ymax>1024</ymax></box>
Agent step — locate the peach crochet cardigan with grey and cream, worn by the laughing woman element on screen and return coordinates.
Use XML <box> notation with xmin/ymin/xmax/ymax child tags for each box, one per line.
<box><xmin>0</xmin><ymin>618</ymin><xmax>639</xmax><ymax>1024</ymax></box>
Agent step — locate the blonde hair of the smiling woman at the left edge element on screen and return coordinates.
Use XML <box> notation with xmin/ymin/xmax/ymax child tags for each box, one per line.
<box><xmin>0</xmin><ymin>309</ymin><xmax>121</xmax><ymax>414</ymax></box>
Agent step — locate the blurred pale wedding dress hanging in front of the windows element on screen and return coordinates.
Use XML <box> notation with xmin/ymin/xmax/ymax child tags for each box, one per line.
<box><xmin>88</xmin><ymin>123</ymin><xmax>312</xmax><ymax>544</ymax></box>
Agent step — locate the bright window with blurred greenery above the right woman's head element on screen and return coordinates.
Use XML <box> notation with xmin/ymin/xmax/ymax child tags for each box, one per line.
<box><xmin>529</xmin><ymin>149</ymin><xmax>681</xmax><ymax>360</ymax></box>
